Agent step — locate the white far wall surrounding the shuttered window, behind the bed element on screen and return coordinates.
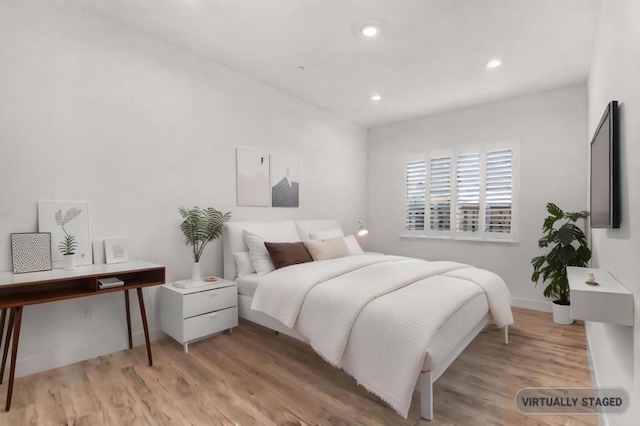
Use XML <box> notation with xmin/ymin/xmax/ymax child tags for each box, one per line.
<box><xmin>369</xmin><ymin>86</ymin><xmax>587</xmax><ymax>309</ymax></box>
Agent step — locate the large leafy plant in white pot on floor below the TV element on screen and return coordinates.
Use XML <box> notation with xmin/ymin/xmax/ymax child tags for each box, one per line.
<box><xmin>531</xmin><ymin>203</ymin><xmax>591</xmax><ymax>324</ymax></box>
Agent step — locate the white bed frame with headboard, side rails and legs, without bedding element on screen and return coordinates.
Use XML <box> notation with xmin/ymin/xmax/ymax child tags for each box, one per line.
<box><xmin>222</xmin><ymin>220</ymin><xmax>509</xmax><ymax>420</ymax></box>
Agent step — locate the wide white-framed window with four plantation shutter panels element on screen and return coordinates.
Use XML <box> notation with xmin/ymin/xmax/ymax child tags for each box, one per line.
<box><xmin>403</xmin><ymin>142</ymin><xmax>518</xmax><ymax>241</ymax></box>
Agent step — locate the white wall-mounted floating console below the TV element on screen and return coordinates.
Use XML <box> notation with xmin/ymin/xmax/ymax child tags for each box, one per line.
<box><xmin>567</xmin><ymin>266</ymin><xmax>633</xmax><ymax>326</ymax></box>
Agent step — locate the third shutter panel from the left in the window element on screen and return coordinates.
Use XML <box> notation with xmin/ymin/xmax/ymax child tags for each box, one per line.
<box><xmin>456</xmin><ymin>152</ymin><xmax>480</xmax><ymax>232</ymax></box>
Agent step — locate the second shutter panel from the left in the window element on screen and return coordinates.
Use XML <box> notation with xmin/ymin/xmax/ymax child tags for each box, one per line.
<box><xmin>429</xmin><ymin>155</ymin><xmax>452</xmax><ymax>231</ymax></box>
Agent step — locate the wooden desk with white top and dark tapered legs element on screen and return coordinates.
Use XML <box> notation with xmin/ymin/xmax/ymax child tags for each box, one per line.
<box><xmin>0</xmin><ymin>262</ymin><xmax>165</xmax><ymax>411</ymax></box>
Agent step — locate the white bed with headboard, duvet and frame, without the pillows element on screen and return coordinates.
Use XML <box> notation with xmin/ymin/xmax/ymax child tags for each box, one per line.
<box><xmin>223</xmin><ymin>220</ymin><xmax>513</xmax><ymax>420</ymax></box>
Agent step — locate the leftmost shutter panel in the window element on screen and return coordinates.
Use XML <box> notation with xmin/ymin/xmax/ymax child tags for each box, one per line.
<box><xmin>404</xmin><ymin>155</ymin><xmax>427</xmax><ymax>231</ymax></box>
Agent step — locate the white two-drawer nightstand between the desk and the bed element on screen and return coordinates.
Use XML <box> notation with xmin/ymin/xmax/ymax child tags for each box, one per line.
<box><xmin>160</xmin><ymin>278</ymin><xmax>238</xmax><ymax>353</ymax></box>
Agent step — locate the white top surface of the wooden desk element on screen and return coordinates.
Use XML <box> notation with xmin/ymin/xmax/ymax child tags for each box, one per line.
<box><xmin>0</xmin><ymin>261</ymin><xmax>163</xmax><ymax>287</ymax></box>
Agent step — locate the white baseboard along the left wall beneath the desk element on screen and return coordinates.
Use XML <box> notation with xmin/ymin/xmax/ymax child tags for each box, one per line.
<box><xmin>13</xmin><ymin>328</ymin><xmax>166</xmax><ymax>377</ymax></box>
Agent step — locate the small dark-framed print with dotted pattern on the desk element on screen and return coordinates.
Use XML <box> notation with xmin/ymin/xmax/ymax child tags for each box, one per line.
<box><xmin>11</xmin><ymin>232</ymin><xmax>52</xmax><ymax>274</ymax></box>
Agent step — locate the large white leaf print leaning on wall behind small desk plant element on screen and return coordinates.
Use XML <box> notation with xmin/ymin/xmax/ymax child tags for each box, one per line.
<box><xmin>38</xmin><ymin>201</ymin><xmax>91</xmax><ymax>266</ymax></box>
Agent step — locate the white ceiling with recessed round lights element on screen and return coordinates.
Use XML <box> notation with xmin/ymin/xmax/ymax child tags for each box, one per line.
<box><xmin>66</xmin><ymin>0</ymin><xmax>601</xmax><ymax>127</ymax></box>
